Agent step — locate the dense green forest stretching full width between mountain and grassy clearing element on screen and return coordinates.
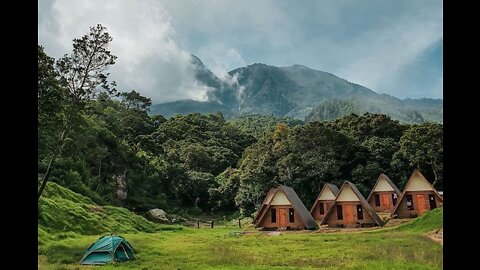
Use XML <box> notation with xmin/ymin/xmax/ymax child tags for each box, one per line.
<box><xmin>38</xmin><ymin>25</ymin><xmax>443</xmax><ymax>218</ymax></box>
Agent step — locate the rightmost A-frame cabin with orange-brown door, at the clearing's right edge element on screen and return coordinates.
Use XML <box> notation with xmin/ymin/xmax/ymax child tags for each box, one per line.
<box><xmin>392</xmin><ymin>170</ymin><xmax>443</xmax><ymax>218</ymax></box>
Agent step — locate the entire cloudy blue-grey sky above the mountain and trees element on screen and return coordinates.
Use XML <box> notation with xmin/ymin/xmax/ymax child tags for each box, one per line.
<box><xmin>38</xmin><ymin>0</ymin><xmax>443</xmax><ymax>103</ymax></box>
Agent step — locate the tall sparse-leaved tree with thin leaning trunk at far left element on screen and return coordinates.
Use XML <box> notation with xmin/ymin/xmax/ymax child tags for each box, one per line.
<box><xmin>38</xmin><ymin>24</ymin><xmax>117</xmax><ymax>201</ymax></box>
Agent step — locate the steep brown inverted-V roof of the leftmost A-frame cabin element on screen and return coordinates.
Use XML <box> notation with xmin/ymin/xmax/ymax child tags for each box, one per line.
<box><xmin>254</xmin><ymin>185</ymin><xmax>318</xmax><ymax>229</ymax></box>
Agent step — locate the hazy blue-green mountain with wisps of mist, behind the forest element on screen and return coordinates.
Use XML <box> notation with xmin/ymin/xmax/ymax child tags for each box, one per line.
<box><xmin>151</xmin><ymin>56</ymin><xmax>443</xmax><ymax>122</ymax></box>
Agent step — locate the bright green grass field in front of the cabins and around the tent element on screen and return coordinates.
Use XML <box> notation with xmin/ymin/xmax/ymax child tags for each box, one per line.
<box><xmin>38</xmin><ymin>182</ymin><xmax>443</xmax><ymax>270</ymax></box>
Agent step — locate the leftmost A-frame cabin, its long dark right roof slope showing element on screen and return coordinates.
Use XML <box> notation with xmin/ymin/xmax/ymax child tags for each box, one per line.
<box><xmin>253</xmin><ymin>185</ymin><xmax>318</xmax><ymax>230</ymax></box>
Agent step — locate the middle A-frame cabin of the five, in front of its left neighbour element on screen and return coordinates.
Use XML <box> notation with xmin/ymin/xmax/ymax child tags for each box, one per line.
<box><xmin>320</xmin><ymin>181</ymin><xmax>384</xmax><ymax>227</ymax></box>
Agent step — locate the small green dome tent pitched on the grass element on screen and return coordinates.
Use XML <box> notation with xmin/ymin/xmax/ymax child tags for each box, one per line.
<box><xmin>80</xmin><ymin>235</ymin><xmax>135</xmax><ymax>264</ymax></box>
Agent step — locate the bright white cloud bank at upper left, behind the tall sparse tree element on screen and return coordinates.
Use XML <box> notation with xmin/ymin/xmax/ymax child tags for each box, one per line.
<box><xmin>38</xmin><ymin>0</ymin><xmax>208</xmax><ymax>103</ymax></box>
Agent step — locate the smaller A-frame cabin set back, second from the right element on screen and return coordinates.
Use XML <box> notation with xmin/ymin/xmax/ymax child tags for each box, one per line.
<box><xmin>367</xmin><ymin>173</ymin><xmax>402</xmax><ymax>212</ymax></box>
